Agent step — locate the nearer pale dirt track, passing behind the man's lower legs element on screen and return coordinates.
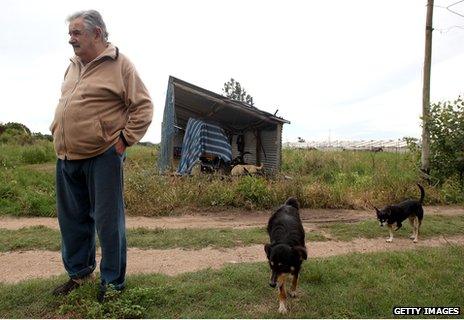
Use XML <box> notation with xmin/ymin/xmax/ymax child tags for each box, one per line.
<box><xmin>0</xmin><ymin>236</ymin><xmax>464</xmax><ymax>283</ymax></box>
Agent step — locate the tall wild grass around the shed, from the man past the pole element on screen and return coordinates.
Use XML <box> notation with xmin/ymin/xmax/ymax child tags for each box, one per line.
<box><xmin>125</xmin><ymin>149</ymin><xmax>446</xmax><ymax>216</ymax></box>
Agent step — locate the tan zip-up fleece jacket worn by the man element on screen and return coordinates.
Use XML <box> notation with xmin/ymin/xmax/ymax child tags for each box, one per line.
<box><xmin>50</xmin><ymin>44</ymin><xmax>153</xmax><ymax>160</ymax></box>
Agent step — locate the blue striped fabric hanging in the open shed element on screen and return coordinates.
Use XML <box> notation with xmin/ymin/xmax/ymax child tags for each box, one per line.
<box><xmin>177</xmin><ymin>118</ymin><xmax>232</xmax><ymax>175</ymax></box>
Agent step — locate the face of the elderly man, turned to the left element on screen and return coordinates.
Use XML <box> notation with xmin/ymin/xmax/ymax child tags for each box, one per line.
<box><xmin>69</xmin><ymin>17</ymin><xmax>95</xmax><ymax>62</ymax></box>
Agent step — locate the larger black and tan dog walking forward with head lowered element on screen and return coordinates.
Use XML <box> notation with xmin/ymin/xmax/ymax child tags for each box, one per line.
<box><xmin>264</xmin><ymin>198</ymin><xmax>308</xmax><ymax>313</ymax></box>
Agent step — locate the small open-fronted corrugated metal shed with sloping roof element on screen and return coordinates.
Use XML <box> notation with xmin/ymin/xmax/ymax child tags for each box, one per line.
<box><xmin>159</xmin><ymin>76</ymin><xmax>290</xmax><ymax>173</ymax></box>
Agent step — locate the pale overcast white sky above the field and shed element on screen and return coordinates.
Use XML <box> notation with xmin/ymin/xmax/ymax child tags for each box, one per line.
<box><xmin>0</xmin><ymin>0</ymin><xmax>464</xmax><ymax>143</ymax></box>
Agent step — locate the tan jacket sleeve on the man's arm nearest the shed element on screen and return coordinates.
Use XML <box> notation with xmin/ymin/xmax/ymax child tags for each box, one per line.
<box><xmin>121</xmin><ymin>64</ymin><xmax>153</xmax><ymax>146</ymax></box>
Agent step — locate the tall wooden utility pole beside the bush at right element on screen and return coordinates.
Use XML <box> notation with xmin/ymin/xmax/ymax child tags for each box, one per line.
<box><xmin>421</xmin><ymin>0</ymin><xmax>433</xmax><ymax>178</ymax></box>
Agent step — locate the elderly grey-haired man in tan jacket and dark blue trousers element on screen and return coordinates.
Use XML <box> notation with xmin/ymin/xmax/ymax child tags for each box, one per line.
<box><xmin>50</xmin><ymin>10</ymin><xmax>153</xmax><ymax>302</ymax></box>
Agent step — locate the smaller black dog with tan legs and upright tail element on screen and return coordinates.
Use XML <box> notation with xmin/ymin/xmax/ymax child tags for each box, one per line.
<box><xmin>374</xmin><ymin>184</ymin><xmax>425</xmax><ymax>242</ymax></box>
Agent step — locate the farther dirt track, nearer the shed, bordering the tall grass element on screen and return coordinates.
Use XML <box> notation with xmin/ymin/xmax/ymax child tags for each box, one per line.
<box><xmin>0</xmin><ymin>206</ymin><xmax>464</xmax><ymax>229</ymax></box>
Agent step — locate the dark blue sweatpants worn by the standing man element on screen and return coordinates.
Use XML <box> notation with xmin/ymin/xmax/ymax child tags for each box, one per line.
<box><xmin>56</xmin><ymin>146</ymin><xmax>127</xmax><ymax>289</ymax></box>
